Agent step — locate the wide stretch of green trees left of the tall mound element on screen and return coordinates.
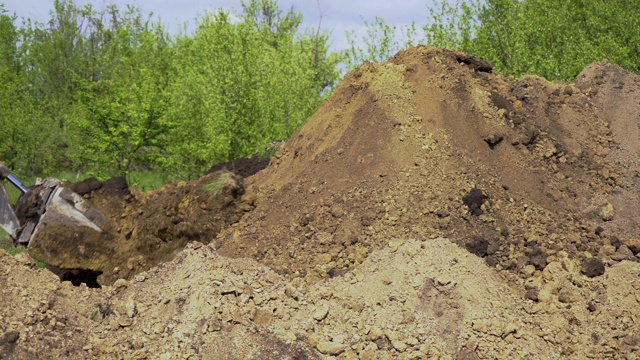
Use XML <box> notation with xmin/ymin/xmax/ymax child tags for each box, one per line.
<box><xmin>0</xmin><ymin>0</ymin><xmax>339</xmax><ymax>179</ymax></box>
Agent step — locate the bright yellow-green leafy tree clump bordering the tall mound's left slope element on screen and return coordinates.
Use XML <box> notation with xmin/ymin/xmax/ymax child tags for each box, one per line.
<box><xmin>166</xmin><ymin>0</ymin><xmax>338</xmax><ymax>176</ymax></box>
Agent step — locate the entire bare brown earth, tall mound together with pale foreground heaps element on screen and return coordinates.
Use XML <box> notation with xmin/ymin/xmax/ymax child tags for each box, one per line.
<box><xmin>0</xmin><ymin>47</ymin><xmax>640</xmax><ymax>359</ymax></box>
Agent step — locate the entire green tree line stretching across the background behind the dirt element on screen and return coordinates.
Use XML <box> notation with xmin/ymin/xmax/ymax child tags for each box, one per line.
<box><xmin>0</xmin><ymin>0</ymin><xmax>640</xmax><ymax>180</ymax></box>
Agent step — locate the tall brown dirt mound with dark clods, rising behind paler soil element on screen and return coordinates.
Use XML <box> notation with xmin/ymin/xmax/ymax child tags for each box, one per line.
<box><xmin>216</xmin><ymin>47</ymin><xmax>640</xmax><ymax>281</ymax></box>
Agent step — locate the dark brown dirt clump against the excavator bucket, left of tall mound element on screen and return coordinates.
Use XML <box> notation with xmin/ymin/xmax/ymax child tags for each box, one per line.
<box><xmin>29</xmin><ymin>172</ymin><xmax>251</xmax><ymax>286</ymax></box>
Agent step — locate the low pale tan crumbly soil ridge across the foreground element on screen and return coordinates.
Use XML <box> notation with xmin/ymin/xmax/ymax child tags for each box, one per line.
<box><xmin>0</xmin><ymin>239</ymin><xmax>640</xmax><ymax>359</ymax></box>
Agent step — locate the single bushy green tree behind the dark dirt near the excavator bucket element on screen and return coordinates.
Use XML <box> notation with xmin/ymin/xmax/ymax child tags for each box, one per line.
<box><xmin>72</xmin><ymin>5</ymin><xmax>173</xmax><ymax>179</ymax></box>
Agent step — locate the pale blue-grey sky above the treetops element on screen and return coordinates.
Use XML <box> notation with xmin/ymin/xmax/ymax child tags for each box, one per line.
<box><xmin>0</xmin><ymin>0</ymin><xmax>433</xmax><ymax>51</ymax></box>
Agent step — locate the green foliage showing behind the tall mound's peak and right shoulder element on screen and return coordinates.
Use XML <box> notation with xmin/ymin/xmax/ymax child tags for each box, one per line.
<box><xmin>345</xmin><ymin>0</ymin><xmax>640</xmax><ymax>81</ymax></box>
